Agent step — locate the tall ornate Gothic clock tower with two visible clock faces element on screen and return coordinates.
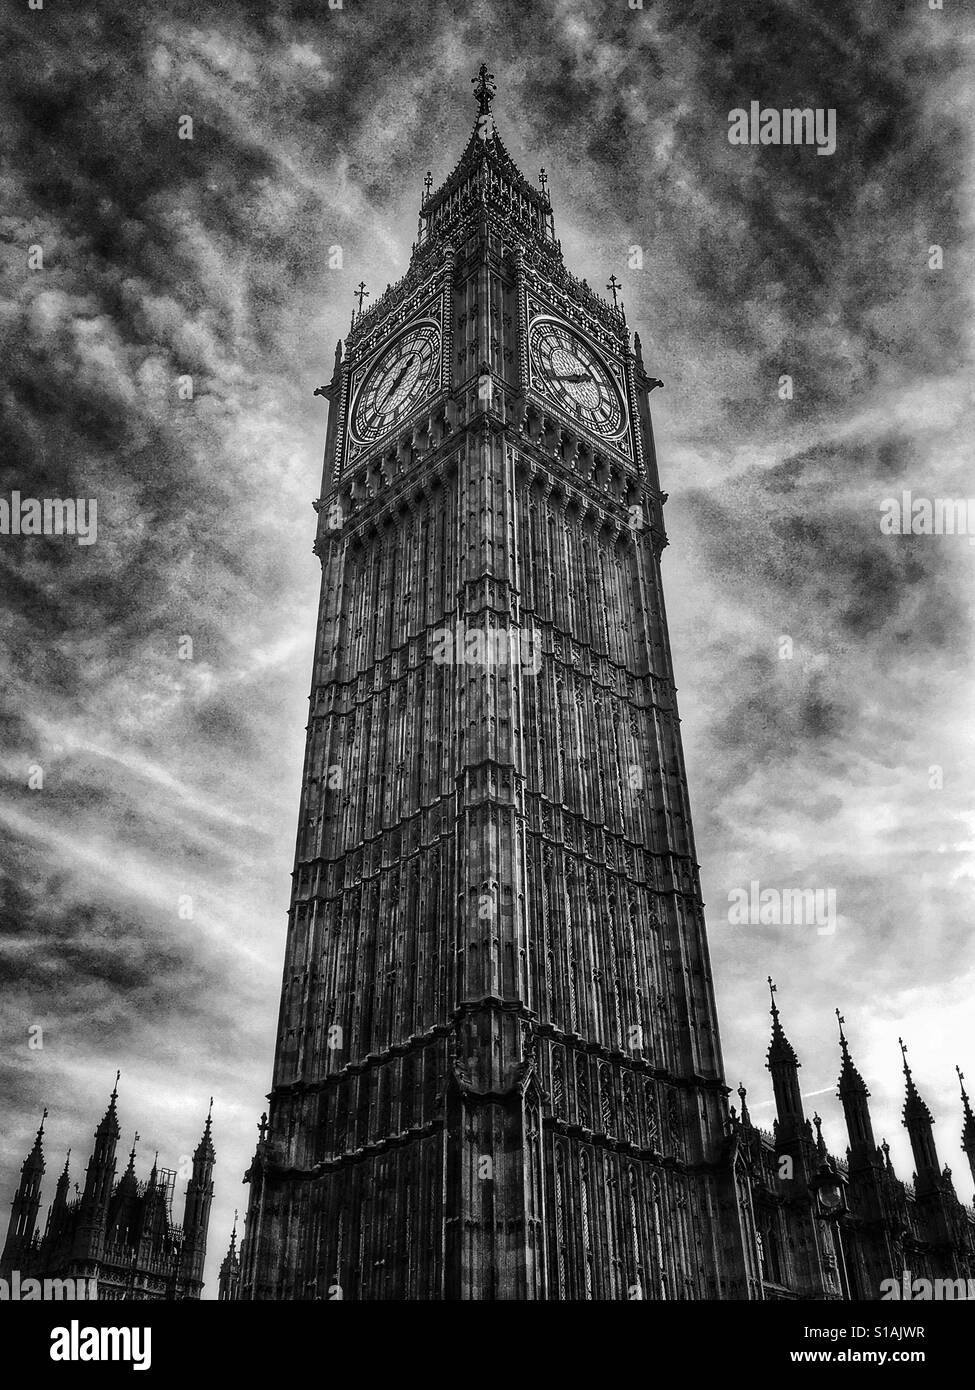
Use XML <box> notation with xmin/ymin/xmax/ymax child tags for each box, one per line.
<box><xmin>239</xmin><ymin>67</ymin><xmax>754</xmax><ymax>1300</ymax></box>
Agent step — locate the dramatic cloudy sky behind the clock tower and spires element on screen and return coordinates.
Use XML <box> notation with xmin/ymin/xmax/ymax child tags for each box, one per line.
<box><xmin>0</xmin><ymin>0</ymin><xmax>975</xmax><ymax>1295</ymax></box>
